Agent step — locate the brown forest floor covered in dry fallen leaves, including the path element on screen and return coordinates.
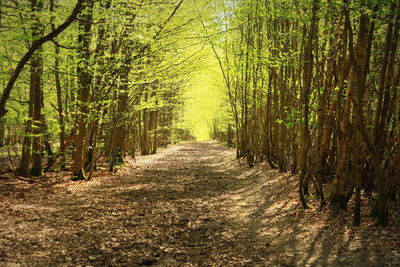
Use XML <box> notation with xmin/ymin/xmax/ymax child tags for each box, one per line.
<box><xmin>0</xmin><ymin>142</ymin><xmax>400</xmax><ymax>267</ymax></box>
